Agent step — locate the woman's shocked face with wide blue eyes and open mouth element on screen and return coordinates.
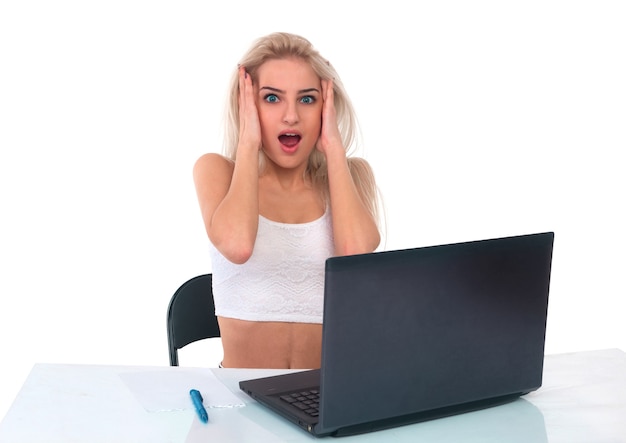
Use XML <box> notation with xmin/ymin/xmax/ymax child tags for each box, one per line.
<box><xmin>255</xmin><ymin>58</ymin><xmax>323</xmax><ymax>168</ymax></box>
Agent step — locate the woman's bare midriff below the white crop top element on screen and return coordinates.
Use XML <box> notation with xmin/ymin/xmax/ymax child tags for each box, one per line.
<box><xmin>218</xmin><ymin>317</ymin><xmax>322</xmax><ymax>369</ymax></box>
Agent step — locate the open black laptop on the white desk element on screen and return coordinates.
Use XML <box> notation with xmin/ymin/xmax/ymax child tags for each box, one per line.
<box><xmin>239</xmin><ymin>232</ymin><xmax>554</xmax><ymax>437</ymax></box>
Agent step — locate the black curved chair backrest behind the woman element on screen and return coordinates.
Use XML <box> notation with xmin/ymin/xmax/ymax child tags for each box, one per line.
<box><xmin>167</xmin><ymin>274</ymin><xmax>220</xmax><ymax>366</ymax></box>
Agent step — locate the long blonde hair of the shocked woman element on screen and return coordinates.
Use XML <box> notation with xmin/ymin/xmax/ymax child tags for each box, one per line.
<box><xmin>224</xmin><ymin>32</ymin><xmax>379</xmax><ymax>229</ymax></box>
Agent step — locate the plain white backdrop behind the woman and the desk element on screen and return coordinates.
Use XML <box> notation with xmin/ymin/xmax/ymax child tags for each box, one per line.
<box><xmin>0</xmin><ymin>0</ymin><xmax>626</xmax><ymax>417</ymax></box>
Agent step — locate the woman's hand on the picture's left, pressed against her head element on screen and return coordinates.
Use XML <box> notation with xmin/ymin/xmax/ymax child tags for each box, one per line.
<box><xmin>237</xmin><ymin>66</ymin><xmax>261</xmax><ymax>151</ymax></box>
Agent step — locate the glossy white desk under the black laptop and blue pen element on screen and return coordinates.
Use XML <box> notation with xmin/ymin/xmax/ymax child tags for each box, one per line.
<box><xmin>0</xmin><ymin>349</ymin><xmax>626</xmax><ymax>443</ymax></box>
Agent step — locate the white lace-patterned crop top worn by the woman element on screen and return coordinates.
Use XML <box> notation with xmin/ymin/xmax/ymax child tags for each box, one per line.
<box><xmin>210</xmin><ymin>210</ymin><xmax>334</xmax><ymax>323</ymax></box>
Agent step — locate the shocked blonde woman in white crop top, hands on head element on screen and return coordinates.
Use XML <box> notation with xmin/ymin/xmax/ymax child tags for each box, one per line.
<box><xmin>194</xmin><ymin>33</ymin><xmax>380</xmax><ymax>368</ymax></box>
